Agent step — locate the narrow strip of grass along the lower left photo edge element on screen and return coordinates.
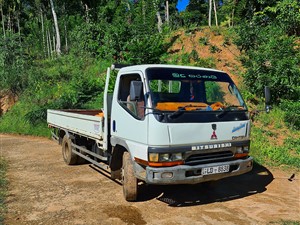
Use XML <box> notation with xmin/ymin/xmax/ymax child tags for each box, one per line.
<box><xmin>0</xmin><ymin>156</ymin><xmax>7</xmax><ymax>224</ymax></box>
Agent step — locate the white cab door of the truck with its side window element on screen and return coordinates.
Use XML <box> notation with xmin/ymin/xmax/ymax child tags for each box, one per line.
<box><xmin>111</xmin><ymin>72</ymin><xmax>147</xmax><ymax>159</ymax></box>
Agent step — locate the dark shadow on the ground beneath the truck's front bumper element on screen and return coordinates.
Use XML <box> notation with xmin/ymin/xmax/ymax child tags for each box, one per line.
<box><xmin>138</xmin><ymin>163</ymin><xmax>274</xmax><ymax>207</ymax></box>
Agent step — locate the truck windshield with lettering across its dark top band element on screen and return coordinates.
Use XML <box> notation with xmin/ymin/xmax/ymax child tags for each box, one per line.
<box><xmin>147</xmin><ymin>68</ymin><xmax>247</xmax><ymax>111</ymax></box>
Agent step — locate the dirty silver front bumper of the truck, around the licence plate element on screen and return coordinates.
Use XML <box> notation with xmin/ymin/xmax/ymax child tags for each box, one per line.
<box><xmin>145</xmin><ymin>157</ymin><xmax>253</xmax><ymax>185</ymax></box>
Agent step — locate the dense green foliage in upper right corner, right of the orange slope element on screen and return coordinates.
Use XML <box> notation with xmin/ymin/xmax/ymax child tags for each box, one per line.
<box><xmin>236</xmin><ymin>0</ymin><xmax>300</xmax><ymax>129</ymax></box>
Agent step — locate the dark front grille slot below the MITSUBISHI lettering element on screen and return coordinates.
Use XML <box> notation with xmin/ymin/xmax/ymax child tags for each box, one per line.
<box><xmin>185</xmin><ymin>151</ymin><xmax>234</xmax><ymax>165</ymax></box>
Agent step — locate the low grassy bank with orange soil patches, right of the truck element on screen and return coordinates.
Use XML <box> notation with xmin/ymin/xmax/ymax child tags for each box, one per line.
<box><xmin>251</xmin><ymin>108</ymin><xmax>300</xmax><ymax>169</ymax></box>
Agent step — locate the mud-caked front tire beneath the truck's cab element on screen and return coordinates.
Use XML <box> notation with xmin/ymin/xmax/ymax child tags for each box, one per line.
<box><xmin>122</xmin><ymin>152</ymin><xmax>138</xmax><ymax>202</ymax></box>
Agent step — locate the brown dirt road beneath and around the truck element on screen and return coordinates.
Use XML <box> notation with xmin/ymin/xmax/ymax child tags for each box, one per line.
<box><xmin>0</xmin><ymin>134</ymin><xmax>300</xmax><ymax>225</ymax></box>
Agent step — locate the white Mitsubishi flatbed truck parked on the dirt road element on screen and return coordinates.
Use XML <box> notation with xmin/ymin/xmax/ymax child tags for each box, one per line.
<box><xmin>47</xmin><ymin>64</ymin><xmax>268</xmax><ymax>201</ymax></box>
